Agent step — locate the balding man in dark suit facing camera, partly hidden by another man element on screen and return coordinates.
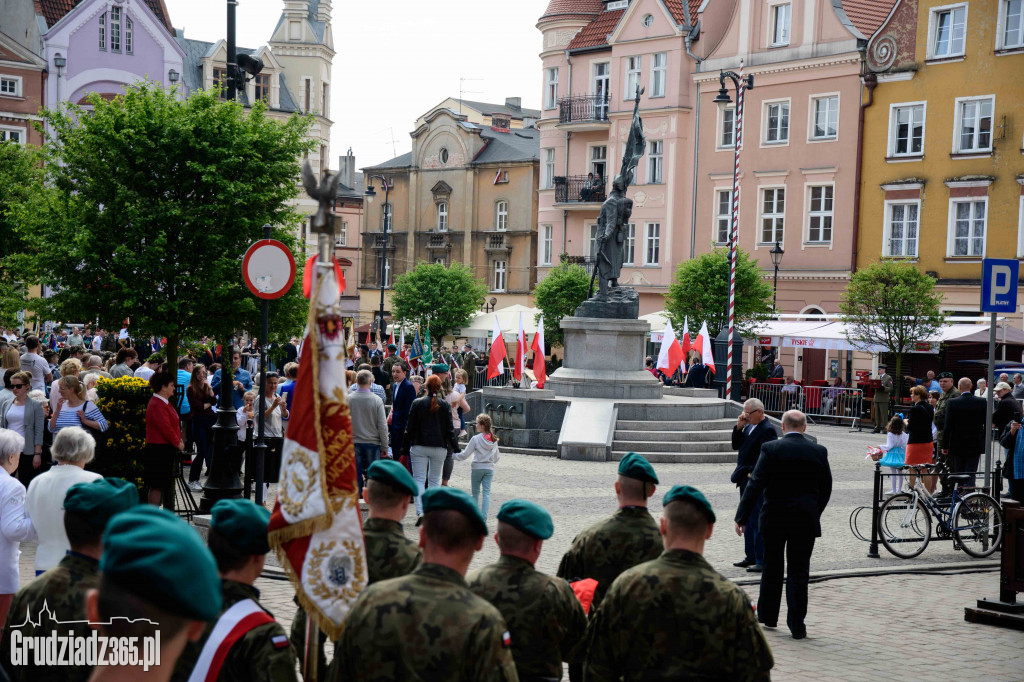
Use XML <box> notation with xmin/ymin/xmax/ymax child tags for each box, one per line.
<box><xmin>729</xmin><ymin>398</ymin><xmax>778</xmax><ymax>573</ymax></box>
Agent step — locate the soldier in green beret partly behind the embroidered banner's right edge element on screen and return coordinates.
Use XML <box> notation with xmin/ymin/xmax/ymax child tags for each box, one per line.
<box><xmin>319</xmin><ymin>460</ymin><xmax>423</xmax><ymax>677</ymax></box>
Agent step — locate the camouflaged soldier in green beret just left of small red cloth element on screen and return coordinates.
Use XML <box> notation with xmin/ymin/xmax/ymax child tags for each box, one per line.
<box><xmin>467</xmin><ymin>500</ymin><xmax>587</xmax><ymax>682</ymax></box>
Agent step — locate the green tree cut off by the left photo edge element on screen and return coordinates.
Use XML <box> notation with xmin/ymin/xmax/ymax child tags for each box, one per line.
<box><xmin>0</xmin><ymin>141</ymin><xmax>46</xmax><ymax>326</ymax></box>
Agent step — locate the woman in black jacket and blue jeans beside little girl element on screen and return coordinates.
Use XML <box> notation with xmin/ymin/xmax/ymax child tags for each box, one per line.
<box><xmin>401</xmin><ymin>375</ymin><xmax>459</xmax><ymax>516</ymax></box>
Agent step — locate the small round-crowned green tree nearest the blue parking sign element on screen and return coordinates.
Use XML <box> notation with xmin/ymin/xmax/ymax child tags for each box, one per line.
<box><xmin>839</xmin><ymin>260</ymin><xmax>945</xmax><ymax>395</ymax></box>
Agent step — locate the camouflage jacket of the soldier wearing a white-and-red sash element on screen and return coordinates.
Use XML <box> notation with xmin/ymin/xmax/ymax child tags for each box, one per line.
<box><xmin>171</xmin><ymin>579</ymin><xmax>299</xmax><ymax>682</ymax></box>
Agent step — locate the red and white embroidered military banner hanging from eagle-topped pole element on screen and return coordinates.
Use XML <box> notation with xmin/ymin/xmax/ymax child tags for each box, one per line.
<box><xmin>268</xmin><ymin>260</ymin><xmax>367</xmax><ymax>640</ymax></box>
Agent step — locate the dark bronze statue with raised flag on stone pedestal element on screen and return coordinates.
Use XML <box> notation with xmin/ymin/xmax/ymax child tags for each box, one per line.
<box><xmin>575</xmin><ymin>86</ymin><xmax>647</xmax><ymax>318</ymax></box>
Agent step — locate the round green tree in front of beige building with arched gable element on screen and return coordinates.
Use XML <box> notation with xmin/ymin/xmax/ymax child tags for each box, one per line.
<box><xmin>391</xmin><ymin>261</ymin><xmax>487</xmax><ymax>339</ymax></box>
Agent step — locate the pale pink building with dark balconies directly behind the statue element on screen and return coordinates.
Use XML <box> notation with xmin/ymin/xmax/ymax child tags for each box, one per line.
<box><xmin>538</xmin><ymin>0</ymin><xmax>700</xmax><ymax>314</ymax></box>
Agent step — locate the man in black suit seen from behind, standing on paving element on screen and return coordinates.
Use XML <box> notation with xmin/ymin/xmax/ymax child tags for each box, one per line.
<box><xmin>735</xmin><ymin>410</ymin><xmax>831</xmax><ymax>639</ymax></box>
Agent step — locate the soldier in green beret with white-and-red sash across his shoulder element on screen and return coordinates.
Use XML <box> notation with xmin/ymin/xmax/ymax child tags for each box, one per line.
<box><xmin>174</xmin><ymin>499</ymin><xmax>299</xmax><ymax>682</ymax></box>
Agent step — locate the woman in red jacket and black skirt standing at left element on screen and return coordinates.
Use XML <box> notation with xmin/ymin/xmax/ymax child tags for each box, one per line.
<box><xmin>143</xmin><ymin>372</ymin><xmax>185</xmax><ymax>507</ymax></box>
